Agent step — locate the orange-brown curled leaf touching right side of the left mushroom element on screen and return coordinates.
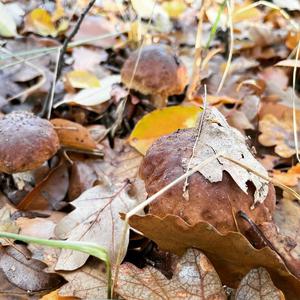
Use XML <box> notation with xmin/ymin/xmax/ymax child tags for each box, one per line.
<box><xmin>51</xmin><ymin>119</ymin><xmax>97</xmax><ymax>150</ymax></box>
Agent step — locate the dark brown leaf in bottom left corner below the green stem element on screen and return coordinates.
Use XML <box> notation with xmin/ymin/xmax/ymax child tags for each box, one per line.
<box><xmin>0</xmin><ymin>245</ymin><xmax>63</xmax><ymax>292</ymax></box>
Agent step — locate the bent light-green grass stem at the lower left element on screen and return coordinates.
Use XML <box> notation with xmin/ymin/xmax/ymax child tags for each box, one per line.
<box><xmin>0</xmin><ymin>232</ymin><xmax>112</xmax><ymax>299</ymax></box>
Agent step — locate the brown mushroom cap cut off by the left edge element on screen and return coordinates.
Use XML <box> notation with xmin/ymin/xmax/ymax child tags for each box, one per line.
<box><xmin>0</xmin><ymin>111</ymin><xmax>60</xmax><ymax>174</ymax></box>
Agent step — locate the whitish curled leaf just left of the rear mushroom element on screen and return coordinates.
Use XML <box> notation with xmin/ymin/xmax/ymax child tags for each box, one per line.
<box><xmin>54</xmin><ymin>75</ymin><xmax>121</xmax><ymax>108</ymax></box>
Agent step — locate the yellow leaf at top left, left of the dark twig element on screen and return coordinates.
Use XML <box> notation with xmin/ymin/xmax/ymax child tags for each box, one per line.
<box><xmin>25</xmin><ymin>8</ymin><xmax>57</xmax><ymax>37</ymax></box>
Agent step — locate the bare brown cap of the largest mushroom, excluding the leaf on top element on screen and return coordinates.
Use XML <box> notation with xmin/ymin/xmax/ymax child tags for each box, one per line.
<box><xmin>140</xmin><ymin>129</ymin><xmax>275</xmax><ymax>233</ymax></box>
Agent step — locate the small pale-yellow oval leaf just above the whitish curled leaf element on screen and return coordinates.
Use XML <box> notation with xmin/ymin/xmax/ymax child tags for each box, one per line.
<box><xmin>66</xmin><ymin>70</ymin><xmax>100</xmax><ymax>89</ymax></box>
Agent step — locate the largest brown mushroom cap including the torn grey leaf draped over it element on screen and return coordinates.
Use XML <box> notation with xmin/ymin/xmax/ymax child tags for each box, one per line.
<box><xmin>140</xmin><ymin>109</ymin><xmax>275</xmax><ymax>233</ymax></box>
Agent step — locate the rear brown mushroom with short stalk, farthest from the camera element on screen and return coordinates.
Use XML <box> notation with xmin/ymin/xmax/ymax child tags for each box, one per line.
<box><xmin>121</xmin><ymin>44</ymin><xmax>188</xmax><ymax>107</ymax></box>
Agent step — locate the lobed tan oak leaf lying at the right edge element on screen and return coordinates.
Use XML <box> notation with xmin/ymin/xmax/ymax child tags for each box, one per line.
<box><xmin>258</xmin><ymin>114</ymin><xmax>300</xmax><ymax>157</ymax></box>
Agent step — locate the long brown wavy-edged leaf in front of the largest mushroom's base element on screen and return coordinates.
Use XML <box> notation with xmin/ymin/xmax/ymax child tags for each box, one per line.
<box><xmin>129</xmin><ymin>214</ymin><xmax>300</xmax><ymax>300</ymax></box>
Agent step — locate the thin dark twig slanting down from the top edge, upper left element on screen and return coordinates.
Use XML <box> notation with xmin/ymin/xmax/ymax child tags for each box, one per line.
<box><xmin>39</xmin><ymin>0</ymin><xmax>96</xmax><ymax>117</ymax></box>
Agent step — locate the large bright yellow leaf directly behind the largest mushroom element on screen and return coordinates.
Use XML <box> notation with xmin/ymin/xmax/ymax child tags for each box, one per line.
<box><xmin>129</xmin><ymin>106</ymin><xmax>201</xmax><ymax>154</ymax></box>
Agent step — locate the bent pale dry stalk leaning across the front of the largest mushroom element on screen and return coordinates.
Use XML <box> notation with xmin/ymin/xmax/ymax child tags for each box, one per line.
<box><xmin>112</xmin><ymin>152</ymin><xmax>223</xmax><ymax>292</ymax></box>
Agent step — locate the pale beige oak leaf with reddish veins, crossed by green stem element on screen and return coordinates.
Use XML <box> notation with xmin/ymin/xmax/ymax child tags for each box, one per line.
<box><xmin>55</xmin><ymin>184</ymin><xmax>141</xmax><ymax>270</ymax></box>
